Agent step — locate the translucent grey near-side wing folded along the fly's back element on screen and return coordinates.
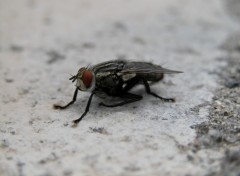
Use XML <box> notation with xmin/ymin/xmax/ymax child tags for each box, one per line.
<box><xmin>119</xmin><ymin>62</ymin><xmax>182</xmax><ymax>74</ymax></box>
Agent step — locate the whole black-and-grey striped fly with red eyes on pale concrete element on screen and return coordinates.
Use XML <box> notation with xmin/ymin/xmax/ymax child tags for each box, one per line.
<box><xmin>53</xmin><ymin>60</ymin><xmax>182</xmax><ymax>125</ymax></box>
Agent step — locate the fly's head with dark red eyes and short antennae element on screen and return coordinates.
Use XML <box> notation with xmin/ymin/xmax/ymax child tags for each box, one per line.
<box><xmin>69</xmin><ymin>67</ymin><xmax>95</xmax><ymax>91</ymax></box>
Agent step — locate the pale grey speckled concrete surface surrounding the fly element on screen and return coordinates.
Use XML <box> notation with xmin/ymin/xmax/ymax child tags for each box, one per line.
<box><xmin>0</xmin><ymin>0</ymin><xmax>240</xmax><ymax>176</ymax></box>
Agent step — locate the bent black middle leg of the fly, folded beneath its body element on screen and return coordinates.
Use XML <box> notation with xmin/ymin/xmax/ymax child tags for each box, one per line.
<box><xmin>99</xmin><ymin>93</ymin><xmax>142</xmax><ymax>108</ymax></box>
